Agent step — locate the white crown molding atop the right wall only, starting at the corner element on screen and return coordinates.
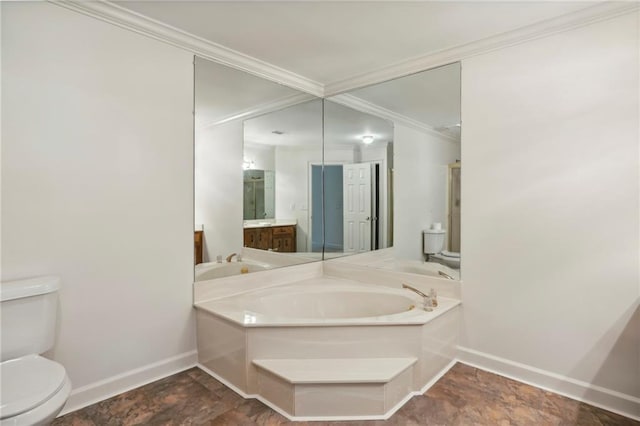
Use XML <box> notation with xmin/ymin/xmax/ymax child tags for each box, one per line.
<box><xmin>324</xmin><ymin>1</ymin><xmax>640</xmax><ymax>96</ymax></box>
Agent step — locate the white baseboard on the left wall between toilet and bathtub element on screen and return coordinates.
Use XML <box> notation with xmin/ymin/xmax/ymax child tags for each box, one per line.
<box><xmin>58</xmin><ymin>351</ymin><xmax>198</xmax><ymax>417</ymax></box>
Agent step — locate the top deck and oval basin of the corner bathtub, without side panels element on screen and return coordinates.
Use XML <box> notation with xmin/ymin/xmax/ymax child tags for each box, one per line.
<box><xmin>196</xmin><ymin>277</ymin><xmax>459</xmax><ymax>327</ymax></box>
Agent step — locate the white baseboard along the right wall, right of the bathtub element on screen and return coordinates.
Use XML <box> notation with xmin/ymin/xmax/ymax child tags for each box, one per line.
<box><xmin>458</xmin><ymin>347</ymin><xmax>640</xmax><ymax>420</ymax></box>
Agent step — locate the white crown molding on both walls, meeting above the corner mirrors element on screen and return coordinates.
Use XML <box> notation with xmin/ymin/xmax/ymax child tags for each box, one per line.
<box><xmin>48</xmin><ymin>0</ymin><xmax>640</xmax><ymax>97</ymax></box>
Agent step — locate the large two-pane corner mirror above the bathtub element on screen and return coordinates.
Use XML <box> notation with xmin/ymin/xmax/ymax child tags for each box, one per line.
<box><xmin>194</xmin><ymin>58</ymin><xmax>462</xmax><ymax>281</ymax></box>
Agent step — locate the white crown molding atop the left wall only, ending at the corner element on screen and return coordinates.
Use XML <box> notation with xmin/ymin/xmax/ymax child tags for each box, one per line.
<box><xmin>48</xmin><ymin>0</ymin><xmax>324</xmax><ymax>96</ymax></box>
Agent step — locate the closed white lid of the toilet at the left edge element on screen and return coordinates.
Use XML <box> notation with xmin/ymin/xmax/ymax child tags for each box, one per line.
<box><xmin>0</xmin><ymin>355</ymin><xmax>66</xmax><ymax>419</ymax></box>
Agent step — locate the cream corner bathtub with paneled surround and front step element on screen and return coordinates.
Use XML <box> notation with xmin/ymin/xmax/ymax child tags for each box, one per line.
<box><xmin>195</xmin><ymin>262</ymin><xmax>460</xmax><ymax>420</ymax></box>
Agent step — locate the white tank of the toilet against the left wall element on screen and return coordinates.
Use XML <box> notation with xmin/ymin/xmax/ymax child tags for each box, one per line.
<box><xmin>0</xmin><ymin>276</ymin><xmax>60</xmax><ymax>361</ymax></box>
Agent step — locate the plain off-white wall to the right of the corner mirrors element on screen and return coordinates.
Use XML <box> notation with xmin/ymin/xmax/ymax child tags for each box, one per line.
<box><xmin>462</xmin><ymin>10</ymin><xmax>640</xmax><ymax>415</ymax></box>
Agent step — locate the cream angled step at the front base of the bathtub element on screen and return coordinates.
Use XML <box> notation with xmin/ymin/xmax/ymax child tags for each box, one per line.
<box><xmin>253</xmin><ymin>358</ymin><xmax>417</xmax><ymax>420</ymax></box>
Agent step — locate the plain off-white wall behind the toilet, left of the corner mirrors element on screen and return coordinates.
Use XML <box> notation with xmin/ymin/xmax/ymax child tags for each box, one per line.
<box><xmin>2</xmin><ymin>2</ymin><xmax>196</xmax><ymax>410</ymax></box>
